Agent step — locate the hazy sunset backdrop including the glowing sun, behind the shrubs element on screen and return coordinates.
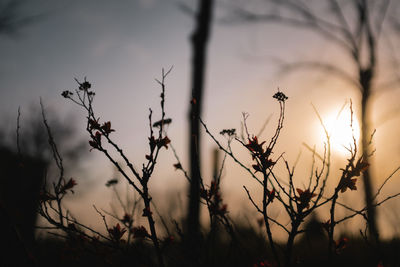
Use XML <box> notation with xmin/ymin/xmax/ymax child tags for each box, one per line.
<box><xmin>0</xmin><ymin>0</ymin><xmax>400</xmax><ymax>242</ymax></box>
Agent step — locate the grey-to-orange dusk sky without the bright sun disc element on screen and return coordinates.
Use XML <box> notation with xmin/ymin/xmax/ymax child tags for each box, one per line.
<box><xmin>0</xmin><ymin>0</ymin><xmax>400</xmax><ymax>239</ymax></box>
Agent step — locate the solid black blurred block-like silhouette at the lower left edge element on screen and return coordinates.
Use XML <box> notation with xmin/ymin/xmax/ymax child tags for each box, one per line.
<box><xmin>0</xmin><ymin>147</ymin><xmax>46</xmax><ymax>266</ymax></box>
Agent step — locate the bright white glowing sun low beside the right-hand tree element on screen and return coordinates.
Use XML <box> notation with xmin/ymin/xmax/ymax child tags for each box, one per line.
<box><xmin>320</xmin><ymin>106</ymin><xmax>360</xmax><ymax>155</ymax></box>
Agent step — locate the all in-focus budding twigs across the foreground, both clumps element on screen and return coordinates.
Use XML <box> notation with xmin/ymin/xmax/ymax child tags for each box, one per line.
<box><xmin>33</xmin><ymin>76</ymin><xmax>400</xmax><ymax>266</ymax></box>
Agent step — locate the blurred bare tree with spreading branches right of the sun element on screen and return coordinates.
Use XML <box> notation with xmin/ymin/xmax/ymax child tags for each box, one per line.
<box><xmin>228</xmin><ymin>0</ymin><xmax>399</xmax><ymax>243</ymax></box>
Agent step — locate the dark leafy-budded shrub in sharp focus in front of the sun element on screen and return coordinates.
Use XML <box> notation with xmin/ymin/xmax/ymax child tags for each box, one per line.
<box><xmin>200</xmin><ymin>91</ymin><xmax>399</xmax><ymax>266</ymax></box>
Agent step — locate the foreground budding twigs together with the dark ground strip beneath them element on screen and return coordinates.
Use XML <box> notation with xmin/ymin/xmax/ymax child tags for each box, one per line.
<box><xmin>23</xmin><ymin>70</ymin><xmax>399</xmax><ymax>266</ymax></box>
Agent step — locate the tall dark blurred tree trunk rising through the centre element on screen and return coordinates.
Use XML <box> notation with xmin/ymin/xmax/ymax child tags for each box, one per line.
<box><xmin>187</xmin><ymin>0</ymin><xmax>213</xmax><ymax>253</ymax></box>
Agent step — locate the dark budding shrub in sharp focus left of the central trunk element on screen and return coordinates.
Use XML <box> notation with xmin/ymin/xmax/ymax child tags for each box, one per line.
<box><xmin>39</xmin><ymin>69</ymin><xmax>175</xmax><ymax>266</ymax></box>
